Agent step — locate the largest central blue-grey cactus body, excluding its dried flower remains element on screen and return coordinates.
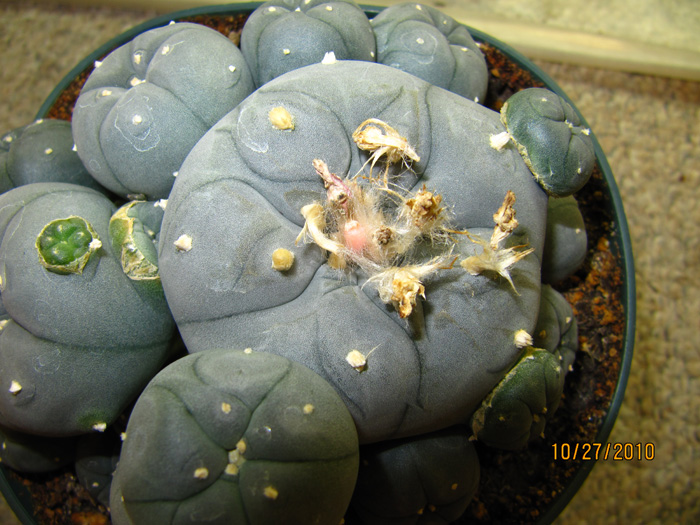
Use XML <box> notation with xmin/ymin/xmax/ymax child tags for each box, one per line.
<box><xmin>159</xmin><ymin>61</ymin><xmax>547</xmax><ymax>442</ymax></box>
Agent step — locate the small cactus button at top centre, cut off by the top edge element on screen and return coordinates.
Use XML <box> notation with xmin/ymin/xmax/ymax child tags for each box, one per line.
<box><xmin>241</xmin><ymin>0</ymin><xmax>376</xmax><ymax>86</ymax></box>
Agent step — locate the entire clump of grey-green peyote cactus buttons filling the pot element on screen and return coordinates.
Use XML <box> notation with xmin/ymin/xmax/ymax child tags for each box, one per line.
<box><xmin>0</xmin><ymin>0</ymin><xmax>594</xmax><ymax>524</ymax></box>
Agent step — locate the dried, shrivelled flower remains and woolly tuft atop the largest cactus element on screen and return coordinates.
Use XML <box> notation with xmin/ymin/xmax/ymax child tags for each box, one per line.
<box><xmin>297</xmin><ymin>119</ymin><xmax>532</xmax><ymax>318</ymax></box>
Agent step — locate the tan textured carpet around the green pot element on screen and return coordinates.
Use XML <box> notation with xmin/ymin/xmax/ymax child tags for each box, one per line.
<box><xmin>0</xmin><ymin>2</ymin><xmax>700</xmax><ymax>524</ymax></box>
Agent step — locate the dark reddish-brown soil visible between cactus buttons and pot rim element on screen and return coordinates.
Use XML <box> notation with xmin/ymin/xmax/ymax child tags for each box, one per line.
<box><xmin>13</xmin><ymin>15</ymin><xmax>625</xmax><ymax>524</ymax></box>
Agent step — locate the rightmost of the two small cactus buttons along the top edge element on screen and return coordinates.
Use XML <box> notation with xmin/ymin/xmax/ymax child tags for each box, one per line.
<box><xmin>372</xmin><ymin>3</ymin><xmax>488</xmax><ymax>101</ymax></box>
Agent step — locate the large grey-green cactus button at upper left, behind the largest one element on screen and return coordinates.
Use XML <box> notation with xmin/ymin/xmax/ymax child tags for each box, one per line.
<box><xmin>72</xmin><ymin>23</ymin><xmax>253</xmax><ymax>199</ymax></box>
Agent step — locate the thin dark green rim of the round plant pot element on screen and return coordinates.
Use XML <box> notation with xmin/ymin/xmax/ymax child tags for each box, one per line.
<box><xmin>5</xmin><ymin>2</ymin><xmax>636</xmax><ymax>525</ymax></box>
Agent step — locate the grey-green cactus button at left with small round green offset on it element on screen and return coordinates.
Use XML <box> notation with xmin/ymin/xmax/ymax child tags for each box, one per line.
<box><xmin>0</xmin><ymin>183</ymin><xmax>174</xmax><ymax>436</ymax></box>
